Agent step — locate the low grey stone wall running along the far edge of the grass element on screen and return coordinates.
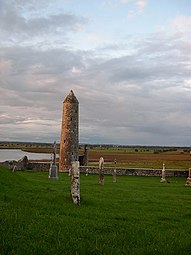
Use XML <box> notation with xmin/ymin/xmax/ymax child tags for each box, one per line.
<box><xmin>1</xmin><ymin>161</ymin><xmax>188</xmax><ymax>178</ymax></box>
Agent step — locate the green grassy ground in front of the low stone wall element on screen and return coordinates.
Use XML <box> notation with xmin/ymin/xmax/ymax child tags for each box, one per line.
<box><xmin>0</xmin><ymin>164</ymin><xmax>191</xmax><ymax>255</ymax></box>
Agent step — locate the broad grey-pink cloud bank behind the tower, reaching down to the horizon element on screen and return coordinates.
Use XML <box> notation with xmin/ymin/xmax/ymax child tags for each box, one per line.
<box><xmin>0</xmin><ymin>14</ymin><xmax>191</xmax><ymax>145</ymax></box>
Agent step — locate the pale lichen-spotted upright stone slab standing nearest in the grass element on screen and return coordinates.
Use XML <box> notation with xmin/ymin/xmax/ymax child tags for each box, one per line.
<box><xmin>70</xmin><ymin>161</ymin><xmax>80</xmax><ymax>205</ymax></box>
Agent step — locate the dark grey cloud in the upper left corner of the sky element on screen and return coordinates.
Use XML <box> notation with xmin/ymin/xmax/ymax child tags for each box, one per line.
<box><xmin>0</xmin><ymin>3</ymin><xmax>87</xmax><ymax>40</ymax></box>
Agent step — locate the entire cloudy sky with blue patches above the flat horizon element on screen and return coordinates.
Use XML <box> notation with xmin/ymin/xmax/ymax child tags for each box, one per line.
<box><xmin>0</xmin><ymin>0</ymin><xmax>191</xmax><ymax>146</ymax></box>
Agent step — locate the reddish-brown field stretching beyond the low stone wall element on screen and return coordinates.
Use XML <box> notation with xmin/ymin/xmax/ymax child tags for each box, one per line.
<box><xmin>0</xmin><ymin>145</ymin><xmax>191</xmax><ymax>169</ymax></box>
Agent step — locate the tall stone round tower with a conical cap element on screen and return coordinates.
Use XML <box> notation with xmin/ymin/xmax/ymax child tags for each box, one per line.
<box><xmin>59</xmin><ymin>90</ymin><xmax>79</xmax><ymax>172</ymax></box>
